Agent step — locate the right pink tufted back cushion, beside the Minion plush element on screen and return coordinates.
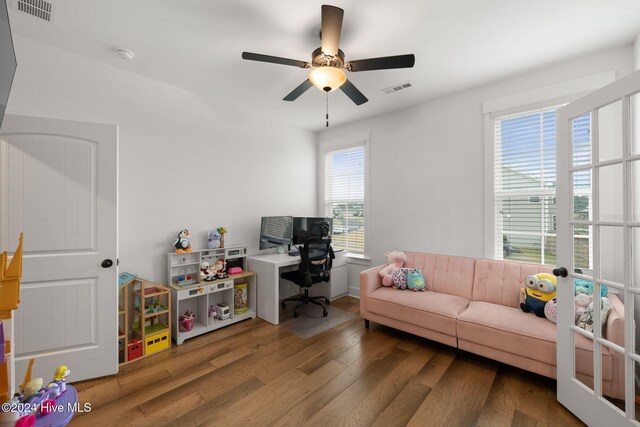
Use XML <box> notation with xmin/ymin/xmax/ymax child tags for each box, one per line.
<box><xmin>471</xmin><ymin>259</ymin><xmax>553</xmax><ymax>308</ymax></box>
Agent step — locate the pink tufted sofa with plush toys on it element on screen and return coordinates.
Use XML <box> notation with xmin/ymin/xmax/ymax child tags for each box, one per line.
<box><xmin>360</xmin><ymin>252</ymin><xmax>624</xmax><ymax>399</ymax></box>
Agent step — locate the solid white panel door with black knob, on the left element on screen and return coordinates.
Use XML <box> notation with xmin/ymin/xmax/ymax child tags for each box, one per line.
<box><xmin>0</xmin><ymin>115</ymin><xmax>118</xmax><ymax>381</ymax></box>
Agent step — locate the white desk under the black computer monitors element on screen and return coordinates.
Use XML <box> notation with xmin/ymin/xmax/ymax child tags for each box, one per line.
<box><xmin>247</xmin><ymin>251</ymin><xmax>348</xmax><ymax>325</ymax></box>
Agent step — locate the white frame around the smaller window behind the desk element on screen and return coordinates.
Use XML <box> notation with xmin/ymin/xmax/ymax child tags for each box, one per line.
<box><xmin>318</xmin><ymin>132</ymin><xmax>371</xmax><ymax>260</ymax></box>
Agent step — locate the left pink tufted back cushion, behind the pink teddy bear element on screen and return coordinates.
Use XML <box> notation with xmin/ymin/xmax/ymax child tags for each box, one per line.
<box><xmin>404</xmin><ymin>252</ymin><xmax>475</xmax><ymax>300</ymax></box>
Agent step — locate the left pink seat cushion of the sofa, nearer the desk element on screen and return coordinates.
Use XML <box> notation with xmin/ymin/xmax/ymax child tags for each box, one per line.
<box><xmin>367</xmin><ymin>287</ymin><xmax>469</xmax><ymax>336</ymax></box>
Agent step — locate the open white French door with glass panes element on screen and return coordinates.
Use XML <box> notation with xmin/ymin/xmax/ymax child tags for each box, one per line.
<box><xmin>557</xmin><ymin>71</ymin><xmax>640</xmax><ymax>426</ymax></box>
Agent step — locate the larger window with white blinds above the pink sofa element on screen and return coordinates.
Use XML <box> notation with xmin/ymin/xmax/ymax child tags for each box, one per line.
<box><xmin>494</xmin><ymin>107</ymin><xmax>558</xmax><ymax>265</ymax></box>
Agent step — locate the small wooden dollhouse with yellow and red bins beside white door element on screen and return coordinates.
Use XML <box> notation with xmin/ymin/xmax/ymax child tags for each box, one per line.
<box><xmin>118</xmin><ymin>273</ymin><xmax>171</xmax><ymax>364</ymax></box>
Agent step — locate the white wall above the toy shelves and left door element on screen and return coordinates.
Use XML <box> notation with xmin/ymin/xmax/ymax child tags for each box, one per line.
<box><xmin>7</xmin><ymin>36</ymin><xmax>317</xmax><ymax>281</ymax></box>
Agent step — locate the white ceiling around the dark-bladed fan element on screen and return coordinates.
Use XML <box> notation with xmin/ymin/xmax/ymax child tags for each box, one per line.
<box><xmin>9</xmin><ymin>0</ymin><xmax>640</xmax><ymax>131</ymax></box>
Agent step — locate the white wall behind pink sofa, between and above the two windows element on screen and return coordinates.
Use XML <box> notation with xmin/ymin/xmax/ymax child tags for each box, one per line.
<box><xmin>319</xmin><ymin>46</ymin><xmax>633</xmax><ymax>274</ymax></box>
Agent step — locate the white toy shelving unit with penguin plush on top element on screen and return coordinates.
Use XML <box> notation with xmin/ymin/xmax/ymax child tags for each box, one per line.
<box><xmin>167</xmin><ymin>246</ymin><xmax>256</xmax><ymax>345</ymax></box>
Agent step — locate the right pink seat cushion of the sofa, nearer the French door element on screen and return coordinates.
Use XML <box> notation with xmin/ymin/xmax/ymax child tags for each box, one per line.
<box><xmin>457</xmin><ymin>301</ymin><xmax>612</xmax><ymax>381</ymax></box>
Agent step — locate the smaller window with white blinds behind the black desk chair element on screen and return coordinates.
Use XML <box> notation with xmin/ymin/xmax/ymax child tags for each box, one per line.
<box><xmin>324</xmin><ymin>145</ymin><xmax>366</xmax><ymax>254</ymax></box>
